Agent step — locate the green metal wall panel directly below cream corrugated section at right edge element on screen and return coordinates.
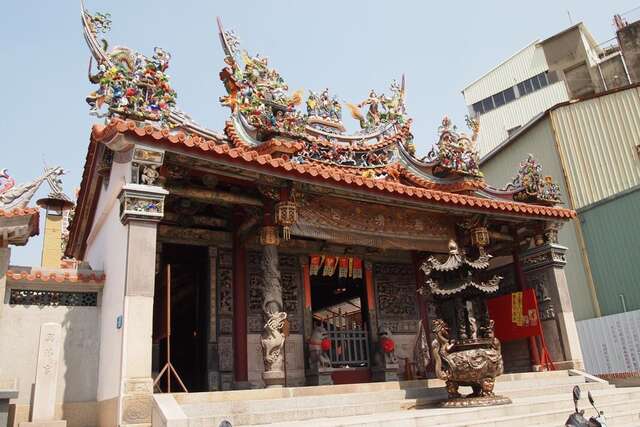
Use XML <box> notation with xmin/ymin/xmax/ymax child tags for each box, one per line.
<box><xmin>578</xmin><ymin>188</ymin><xmax>640</xmax><ymax>315</ymax></box>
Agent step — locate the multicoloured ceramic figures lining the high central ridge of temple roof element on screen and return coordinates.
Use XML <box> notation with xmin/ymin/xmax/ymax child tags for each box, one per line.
<box><xmin>218</xmin><ymin>20</ymin><xmax>406</xmax><ymax>137</ymax></box>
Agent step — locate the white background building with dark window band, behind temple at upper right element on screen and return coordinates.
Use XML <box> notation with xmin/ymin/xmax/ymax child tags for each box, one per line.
<box><xmin>462</xmin><ymin>20</ymin><xmax>640</xmax><ymax>157</ymax></box>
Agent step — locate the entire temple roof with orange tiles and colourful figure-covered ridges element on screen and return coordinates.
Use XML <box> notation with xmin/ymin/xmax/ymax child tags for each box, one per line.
<box><xmin>70</xmin><ymin>7</ymin><xmax>575</xmax><ymax>260</ymax></box>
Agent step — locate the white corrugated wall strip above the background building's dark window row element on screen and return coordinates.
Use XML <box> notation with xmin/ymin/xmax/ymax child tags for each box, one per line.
<box><xmin>462</xmin><ymin>41</ymin><xmax>549</xmax><ymax>104</ymax></box>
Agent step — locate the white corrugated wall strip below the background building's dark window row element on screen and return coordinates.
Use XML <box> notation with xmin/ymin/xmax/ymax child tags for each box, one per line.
<box><xmin>477</xmin><ymin>81</ymin><xmax>569</xmax><ymax>157</ymax></box>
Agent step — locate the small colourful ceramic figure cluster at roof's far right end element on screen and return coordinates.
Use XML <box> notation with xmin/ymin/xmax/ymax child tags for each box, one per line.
<box><xmin>504</xmin><ymin>154</ymin><xmax>561</xmax><ymax>205</ymax></box>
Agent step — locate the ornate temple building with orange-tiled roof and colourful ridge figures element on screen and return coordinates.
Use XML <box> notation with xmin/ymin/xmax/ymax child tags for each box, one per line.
<box><xmin>0</xmin><ymin>5</ymin><xmax>582</xmax><ymax>426</ymax></box>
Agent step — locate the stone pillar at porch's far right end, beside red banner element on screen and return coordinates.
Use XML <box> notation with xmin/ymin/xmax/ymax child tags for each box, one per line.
<box><xmin>521</xmin><ymin>244</ymin><xmax>584</xmax><ymax>369</ymax></box>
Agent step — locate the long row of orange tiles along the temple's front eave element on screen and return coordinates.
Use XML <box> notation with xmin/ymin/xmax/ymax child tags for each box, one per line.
<box><xmin>92</xmin><ymin>119</ymin><xmax>576</xmax><ymax>219</ymax></box>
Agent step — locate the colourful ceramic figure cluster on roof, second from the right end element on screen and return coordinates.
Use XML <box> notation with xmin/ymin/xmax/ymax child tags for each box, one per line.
<box><xmin>425</xmin><ymin>116</ymin><xmax>483</xmax><ymax>177</ymax></box>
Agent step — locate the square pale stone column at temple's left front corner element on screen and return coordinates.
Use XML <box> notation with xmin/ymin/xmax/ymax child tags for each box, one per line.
<box><xmin>114</xmin><ymin>184</ymin><xmax>168</xmax><ymax>425</ymax></box>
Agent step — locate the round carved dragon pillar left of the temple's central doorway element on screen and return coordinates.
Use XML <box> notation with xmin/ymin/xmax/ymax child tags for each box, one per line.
<box><xmin>260</xmin><ymin>226</ymin><xmax>287</xmax><ymax>388</ymax></box>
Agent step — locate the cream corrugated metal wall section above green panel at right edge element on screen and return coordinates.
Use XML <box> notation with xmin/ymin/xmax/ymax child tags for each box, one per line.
<box><xmin>551</xmin><ymin>88</ymin><xmax>640</xmax><ymax>209</ymax></box>
